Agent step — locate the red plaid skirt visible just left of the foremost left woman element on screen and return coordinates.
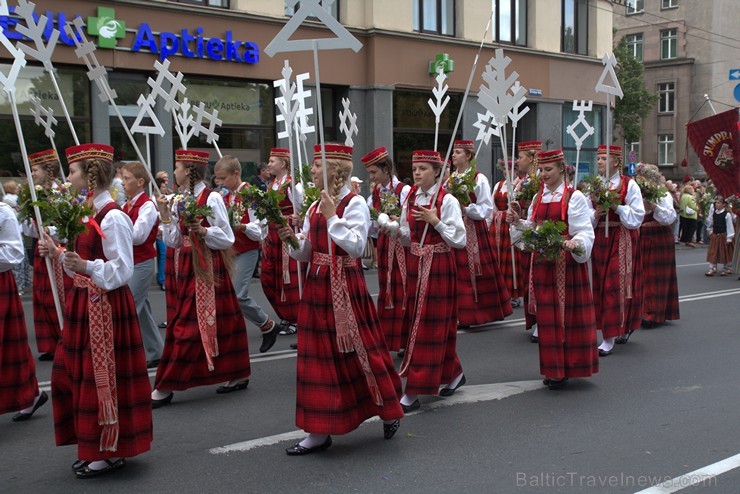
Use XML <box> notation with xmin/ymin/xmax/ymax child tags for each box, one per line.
<box><xmin>33</xmin><ymin>244</ymin><xmax>72</xmax><ymax>353</ymax></box>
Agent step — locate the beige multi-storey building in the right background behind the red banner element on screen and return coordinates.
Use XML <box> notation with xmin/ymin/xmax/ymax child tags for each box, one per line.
<box><xmin>614</xmin><ymin>0</ymin><xmax>740</xmax><ymax>178</ymax></box>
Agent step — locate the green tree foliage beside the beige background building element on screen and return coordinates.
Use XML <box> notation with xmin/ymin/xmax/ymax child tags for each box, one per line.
<box><xmin>614</xmin><ymin>37</ymin><xmax>659</xmax><ymax>142</ymax></box>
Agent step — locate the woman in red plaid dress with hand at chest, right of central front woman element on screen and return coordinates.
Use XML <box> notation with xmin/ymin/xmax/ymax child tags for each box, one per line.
<box><xmin>398</xmin><ymin>151</ymin><xmax>467</xmax><ymax>412</ymax></box>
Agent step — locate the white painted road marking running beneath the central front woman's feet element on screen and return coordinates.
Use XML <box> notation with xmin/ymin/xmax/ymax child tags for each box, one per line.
<box><xmin>208</xmin><ymin>380</ymin><xmax>544</xmax><ymax>455</ymax></box>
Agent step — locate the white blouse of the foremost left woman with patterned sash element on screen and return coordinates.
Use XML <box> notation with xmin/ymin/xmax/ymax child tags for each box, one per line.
<box><xmin>59</xmin><ymin>190</ymin><xmax>134</xmax><ymax>291</ymax></box>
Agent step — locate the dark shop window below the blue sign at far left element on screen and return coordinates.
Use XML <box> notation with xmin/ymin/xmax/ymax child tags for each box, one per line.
<box><xmin>0</xmin><ymin>64</ymin><xmax>90</xmax><ymax>178</ymax></box>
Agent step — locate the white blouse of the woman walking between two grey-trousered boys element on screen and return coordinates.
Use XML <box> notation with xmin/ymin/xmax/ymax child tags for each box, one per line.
<box><xmin>162</xmin><ymin>182</ymin><xmax>234</xmax><ymax>250</ymax></box>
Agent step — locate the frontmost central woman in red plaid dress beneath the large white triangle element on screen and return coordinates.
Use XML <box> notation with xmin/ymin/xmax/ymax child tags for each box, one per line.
<box><xmin>279</xmin><ymin>144</ymin><xmax>403</xmax><ymax>456</ymax></box>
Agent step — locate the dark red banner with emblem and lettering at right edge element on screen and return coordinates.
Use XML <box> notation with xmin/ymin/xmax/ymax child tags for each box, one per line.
<box><xmin>686</xmin><ymin>109</ymin><xmax>740</xmax><ymax>197</ymax></box>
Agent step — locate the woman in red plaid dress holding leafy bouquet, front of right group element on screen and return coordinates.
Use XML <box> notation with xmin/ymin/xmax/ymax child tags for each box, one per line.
<box><xmin>506</xmin><ymin>149</ymin><xmax>599</xmax><ymax>389</ymax></box>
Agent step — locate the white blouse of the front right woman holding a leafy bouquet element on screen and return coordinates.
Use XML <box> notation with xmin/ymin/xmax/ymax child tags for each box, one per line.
<box><xmin>509</xmin><ymin>183</ymin><xmax>595</xmax><ymax>264</ymax></box>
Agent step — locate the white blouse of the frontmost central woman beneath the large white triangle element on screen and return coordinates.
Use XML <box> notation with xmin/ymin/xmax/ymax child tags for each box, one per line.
<box><xmin>290</xmin><ymin>185</ymin><xmax>370</xmax><ymax>262</ymax></box>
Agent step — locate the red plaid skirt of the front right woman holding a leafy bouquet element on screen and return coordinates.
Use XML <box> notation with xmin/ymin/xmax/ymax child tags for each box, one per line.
<box><xmin>532</xmin><ymin>254</ymin><xmax>599</xmax><ymax>379</ymax></box>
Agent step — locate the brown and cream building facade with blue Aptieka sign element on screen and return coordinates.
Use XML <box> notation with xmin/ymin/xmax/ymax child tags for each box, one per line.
<box><xmin>0</xmin><ymin>0</ymin><xmax>613</xmax><ymax>185</ymax></box>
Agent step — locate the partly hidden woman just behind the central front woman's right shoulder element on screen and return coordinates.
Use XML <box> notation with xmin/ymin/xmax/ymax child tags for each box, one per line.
<box><xmin>362</xmin><ymin>147</ymin><xmax>411</xmax><ymax>352</ymax></box>
